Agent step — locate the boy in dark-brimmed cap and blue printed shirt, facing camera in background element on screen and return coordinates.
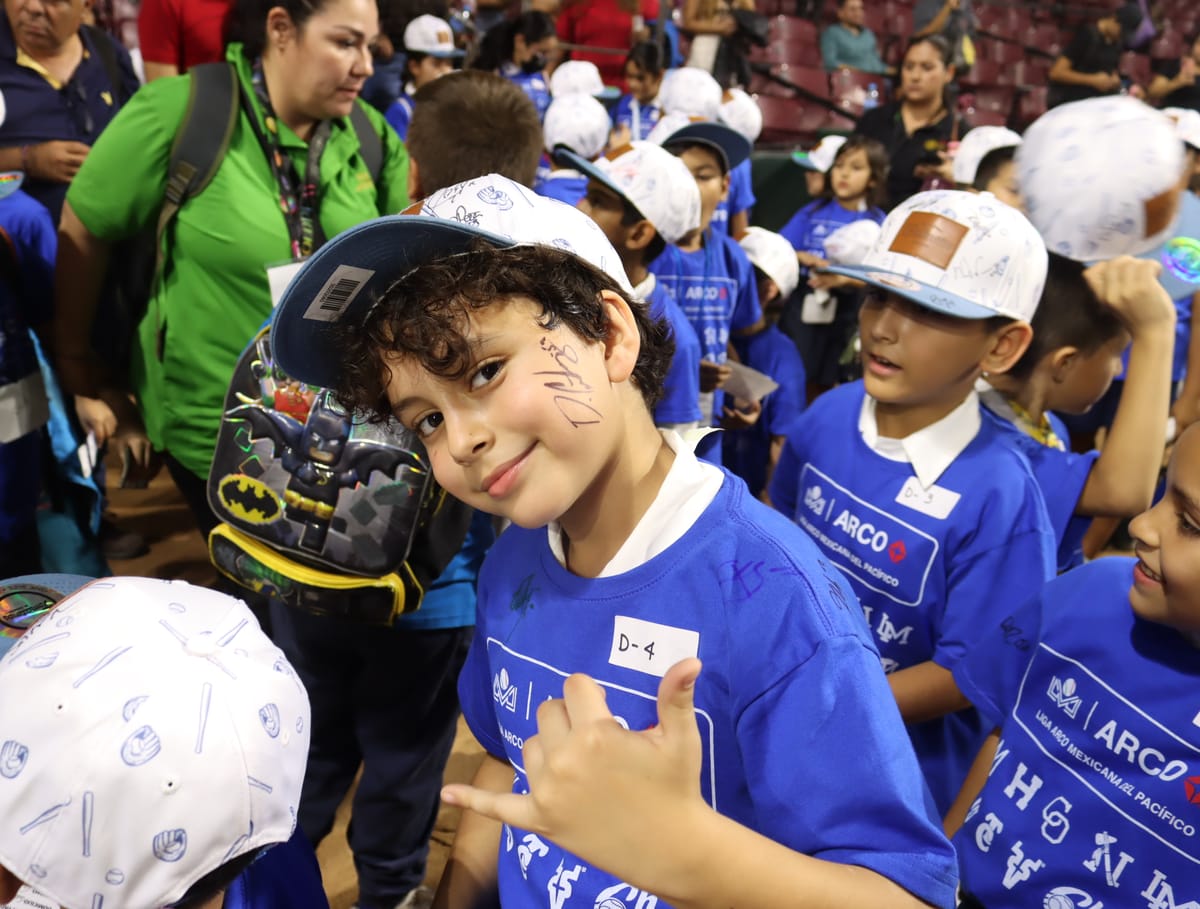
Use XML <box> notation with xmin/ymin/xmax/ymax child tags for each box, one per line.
<box><xmin>650</xmin><ymin>122</ymin><xmax>762</xmax><ymax>463</ymax></box>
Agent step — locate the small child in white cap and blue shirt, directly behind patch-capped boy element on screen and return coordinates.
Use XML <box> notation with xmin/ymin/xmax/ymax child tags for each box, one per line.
<box><xmin>722</xmin><ymin>227</ymin><xmax>805</xmax><ymax>499</ymax></box>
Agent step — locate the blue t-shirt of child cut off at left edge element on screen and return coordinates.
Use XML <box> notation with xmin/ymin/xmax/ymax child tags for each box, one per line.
<box><xmin>0</xmin><ymin>189</ymin><xmax>58</xmax><ymax>385</ymax></box>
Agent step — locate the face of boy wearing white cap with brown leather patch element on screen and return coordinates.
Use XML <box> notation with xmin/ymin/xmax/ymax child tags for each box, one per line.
<box><xmin>858</xmin><ymin>290</ymin><xmax>992</xmax><ymax>410</ymax></box>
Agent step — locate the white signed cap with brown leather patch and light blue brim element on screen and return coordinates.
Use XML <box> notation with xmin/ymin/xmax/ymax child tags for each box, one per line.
<box><xmin>827</xmin><ymin>189</ymin><xmax>1049</xmax><ymax>321</ymax></box>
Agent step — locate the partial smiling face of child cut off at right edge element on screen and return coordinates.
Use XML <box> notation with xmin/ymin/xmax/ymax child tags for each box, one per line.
<box><xmin>1129</xmin><ymin>427</ymin><xmax>1200</xmax><ymax>638</ymax></box>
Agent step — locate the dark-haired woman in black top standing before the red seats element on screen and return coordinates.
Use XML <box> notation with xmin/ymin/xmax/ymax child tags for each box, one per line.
<box><xmin>854</xmin><ymin>35</ymin><xmax>970</xmax><ymax>210</ymax></box>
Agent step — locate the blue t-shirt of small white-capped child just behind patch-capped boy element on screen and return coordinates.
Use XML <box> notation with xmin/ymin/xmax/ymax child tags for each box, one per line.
<box><xmin>722</xmin><ymin>325</ymin><xmax>806</xmax><ymax>496</ymax></box>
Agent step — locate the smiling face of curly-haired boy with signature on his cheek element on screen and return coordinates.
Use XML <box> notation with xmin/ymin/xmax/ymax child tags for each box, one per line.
<box><xmin>384</xmin><ymin>294</ymin><xmax>636</xmax><ymax>528</ymax></box>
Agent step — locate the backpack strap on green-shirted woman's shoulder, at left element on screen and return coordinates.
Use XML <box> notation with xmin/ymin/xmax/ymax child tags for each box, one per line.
<box><xmin>155</xmin><ymin>62</ymin><xmax>240</xmax><ymax>285</ymax></box>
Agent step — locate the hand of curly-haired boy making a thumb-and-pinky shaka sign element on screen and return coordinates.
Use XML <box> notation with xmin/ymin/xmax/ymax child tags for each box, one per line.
<box><xmin>442</xmin><ymin>658</ymin><xmax>709</xmax><ymax>886</ymax></box>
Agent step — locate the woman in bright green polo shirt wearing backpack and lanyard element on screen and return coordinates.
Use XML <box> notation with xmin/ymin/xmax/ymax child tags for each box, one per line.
<box><xmin>55</xmin><ymin>0</ymin><xmax>408</xmax><ymax>535</ymax></box>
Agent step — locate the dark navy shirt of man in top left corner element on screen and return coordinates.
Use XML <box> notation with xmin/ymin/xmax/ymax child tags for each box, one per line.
<box><xmin>0</xmin><ymin>22</ymin><xmax>138</xmax><ymax>224</ymax></box>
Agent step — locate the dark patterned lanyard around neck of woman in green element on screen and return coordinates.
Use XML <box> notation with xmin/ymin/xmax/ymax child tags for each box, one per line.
<box><xmin>248</xmin><ymin>59</ymin><xmax>331</xmax><ymax>259</ymax></box>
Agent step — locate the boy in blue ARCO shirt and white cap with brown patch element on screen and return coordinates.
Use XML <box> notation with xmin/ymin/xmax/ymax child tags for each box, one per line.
<box><xmin>769</xmin><ymin>191</ymin><xmax>1055</xmax><ymax>811</ymax></box>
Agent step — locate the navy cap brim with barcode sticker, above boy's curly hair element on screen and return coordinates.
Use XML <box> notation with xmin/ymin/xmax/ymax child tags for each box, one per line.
<box><xmin>271</xmin><ymin>215</ymin><xmax>516</xmax><ymax>389</ymax></box>
